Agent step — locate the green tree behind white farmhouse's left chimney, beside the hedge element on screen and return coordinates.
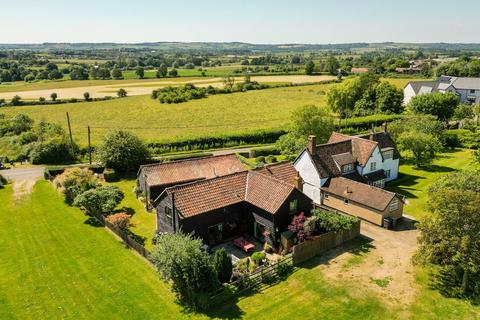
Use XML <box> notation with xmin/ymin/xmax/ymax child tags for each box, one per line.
<box><xmin>276</xmin><ymin>105</ymin><xmax>334</xmax><ymax>155</ymax></box>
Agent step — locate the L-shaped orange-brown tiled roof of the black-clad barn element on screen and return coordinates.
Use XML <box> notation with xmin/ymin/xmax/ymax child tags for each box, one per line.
<box><xmin>165</xmin><ymin>171</ymin><xmax>295</xmax><ymax>218</ymax></box>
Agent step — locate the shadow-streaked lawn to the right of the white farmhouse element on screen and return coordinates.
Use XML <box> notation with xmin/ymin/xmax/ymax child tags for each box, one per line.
<box><xmin>387</xmin><ymin>149</ymin><xmax>475</xmax><ymax>219</ymax></box>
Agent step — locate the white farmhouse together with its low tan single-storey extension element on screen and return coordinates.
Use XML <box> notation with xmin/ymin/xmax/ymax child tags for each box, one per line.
<box><xmin>294</xmin><ymin>124</ymin><xmax>403</xmax><ymax>225</ymax></box>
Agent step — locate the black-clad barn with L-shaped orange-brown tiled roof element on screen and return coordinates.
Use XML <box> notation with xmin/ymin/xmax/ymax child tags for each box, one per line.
<box><xmin>154</xmin><ymin>163</ymin><xmax>312</xmax><ymax>245</ymax></box>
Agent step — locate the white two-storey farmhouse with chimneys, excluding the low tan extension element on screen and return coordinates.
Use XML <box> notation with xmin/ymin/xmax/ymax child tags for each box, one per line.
<box><xmin>294</xmin><ymin>124</ymin><xmax>400</xmax><ymax>204</ymax></box>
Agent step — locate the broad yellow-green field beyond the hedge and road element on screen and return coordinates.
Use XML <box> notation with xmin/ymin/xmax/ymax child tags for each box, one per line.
<box><xmin>0</xmin><ymin>85</ymin><xmax>329</xmax><ymax>145</ymax></box>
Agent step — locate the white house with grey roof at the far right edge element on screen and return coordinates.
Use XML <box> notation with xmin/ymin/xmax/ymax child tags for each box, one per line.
<box><xmin>403</xmin><ymin>76</ymin><xmax>480</xmax><ymax>104</ymax></box>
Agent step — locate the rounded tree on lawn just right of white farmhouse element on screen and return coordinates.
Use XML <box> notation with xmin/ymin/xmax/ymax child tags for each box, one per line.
<box><xmin>397</xmin><ymin>130</ymin><xmax>442</xmax><ymax>166</ymax></box>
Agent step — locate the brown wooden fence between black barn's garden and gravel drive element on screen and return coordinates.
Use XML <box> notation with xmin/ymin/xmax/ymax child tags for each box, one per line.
<box><xmin>292</xmin><ymin>221</ymin><xmax>360</xmax><ymax>265</ymax></box>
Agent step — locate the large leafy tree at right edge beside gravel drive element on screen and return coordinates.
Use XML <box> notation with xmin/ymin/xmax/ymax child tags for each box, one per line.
<box><xmin>416</xmin><ymin>171</ymin><xmax>480</xmax><ymax>299</ymax></box>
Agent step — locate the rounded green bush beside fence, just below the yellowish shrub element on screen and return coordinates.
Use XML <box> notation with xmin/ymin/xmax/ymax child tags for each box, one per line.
<box><xmin>73</xmin><ymin>186</ymin><xmax>125</xmax><ymax>215</ymax></box>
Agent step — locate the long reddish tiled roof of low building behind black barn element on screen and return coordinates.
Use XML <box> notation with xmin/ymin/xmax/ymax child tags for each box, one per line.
<box><xmin>140</xmin><ymin>154</ymin><xmax>246</xmax><ymax>186</ymax></box>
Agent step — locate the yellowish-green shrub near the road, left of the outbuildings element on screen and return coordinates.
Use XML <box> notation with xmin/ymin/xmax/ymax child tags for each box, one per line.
<box><xmin>53</xmin><ymin>168</ymin><xmax>99</xmax><ymax>203</ymax></box>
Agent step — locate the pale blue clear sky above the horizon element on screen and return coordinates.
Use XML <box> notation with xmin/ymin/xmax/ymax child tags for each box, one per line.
<box><xmin>0</xmin><ymin>0</ymin><xmax>480</xmax><ymax>44</ymax></box>
